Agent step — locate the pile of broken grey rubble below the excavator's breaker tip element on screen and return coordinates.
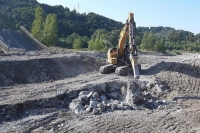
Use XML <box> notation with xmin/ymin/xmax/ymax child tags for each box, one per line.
<box><xmin>69</xmin><ymin>80</ymin><xmax>169</xmax><ymax>115</ymax></box>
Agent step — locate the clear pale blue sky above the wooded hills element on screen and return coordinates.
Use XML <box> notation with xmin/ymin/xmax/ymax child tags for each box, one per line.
<box><xmin>37</xmin><ymin>0</ymin><xmax>200</xmax><ymax>34</ymax></box>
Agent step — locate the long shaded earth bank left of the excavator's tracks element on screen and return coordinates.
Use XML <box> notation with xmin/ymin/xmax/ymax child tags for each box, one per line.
<box><xmin>0</xmin><ymin>55</ymin><xmax>101</xmax><ymax>86</ymax></box>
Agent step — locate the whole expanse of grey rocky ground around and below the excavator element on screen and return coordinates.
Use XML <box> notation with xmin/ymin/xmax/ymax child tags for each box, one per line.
<box><xmin>0</xmin><ymin>52</ymin><xmax>200</xmax><ymax>133</ymax></box>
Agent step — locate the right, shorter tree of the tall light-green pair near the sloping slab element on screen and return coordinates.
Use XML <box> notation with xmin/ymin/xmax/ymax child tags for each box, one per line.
<box><xmin>43</xmin><ymin>14</ymin><xmax>58</xmax><ymax>46</ymax></box>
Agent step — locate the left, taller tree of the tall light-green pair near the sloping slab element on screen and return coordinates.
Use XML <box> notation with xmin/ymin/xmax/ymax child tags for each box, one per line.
<box><xmin>31</xmin><ymin>6</ymin><xmax>44</xmax><ymax>42</ymax></box>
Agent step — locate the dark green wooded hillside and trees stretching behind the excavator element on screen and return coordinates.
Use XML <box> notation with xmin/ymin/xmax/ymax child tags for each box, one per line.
<box><xmin>0</xmin><ymin>0</ymin><xmax>200</xmax><ymax>52</ymax></box>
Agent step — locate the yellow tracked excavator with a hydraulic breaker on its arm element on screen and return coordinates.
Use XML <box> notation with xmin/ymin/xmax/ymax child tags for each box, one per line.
<box><xmin>99</xmin><ymin>13</ymin><xmax>141</xmax><ymax>79</ymax></box>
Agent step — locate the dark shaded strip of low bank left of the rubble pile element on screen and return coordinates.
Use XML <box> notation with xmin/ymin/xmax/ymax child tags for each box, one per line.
<box><xmin>0</xmin><ymin>95</ymin><xmax>71</xmax><ymax>124</ymax></box>
